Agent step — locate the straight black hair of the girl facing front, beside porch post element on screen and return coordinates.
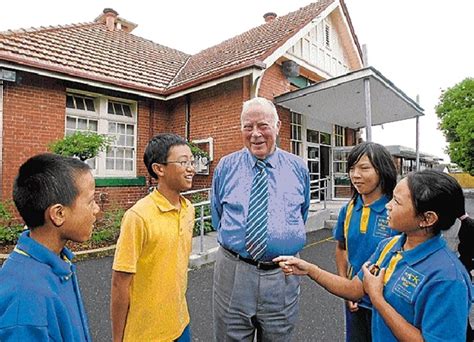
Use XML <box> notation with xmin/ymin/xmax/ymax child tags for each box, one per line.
<box><xmin>347</xmin><ymin>142</ymin><xmax>397</xmax><ymax>199</ymax></box>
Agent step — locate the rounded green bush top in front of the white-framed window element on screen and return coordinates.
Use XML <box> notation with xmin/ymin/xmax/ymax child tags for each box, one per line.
<box><xmin>49</xmin><ymin>132</ymin><xmax>111</xmax><ymax>161</ymax></box>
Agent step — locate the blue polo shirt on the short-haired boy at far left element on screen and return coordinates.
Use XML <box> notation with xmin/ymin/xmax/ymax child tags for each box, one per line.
<box><xmin>0</xmin><ymin>231</ymin><xmax>91</xmax><ymax>342</ymax></box>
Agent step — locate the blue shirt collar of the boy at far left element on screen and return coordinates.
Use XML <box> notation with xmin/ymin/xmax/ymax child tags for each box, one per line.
<box><xmin>17</xmin><ymin>230</ymin><xmax>74</xmax><ymax>280</ymax></box>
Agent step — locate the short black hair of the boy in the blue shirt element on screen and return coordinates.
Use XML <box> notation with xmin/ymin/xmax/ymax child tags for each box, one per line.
<box><xmin>13</xmin><ymin>153</ymin><xmax>90</xmax><ymax>229</ymax></box>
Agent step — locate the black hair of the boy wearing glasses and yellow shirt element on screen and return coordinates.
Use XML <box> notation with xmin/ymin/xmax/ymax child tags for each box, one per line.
<box><xmin>143</xmin><ymin>133</ymin><xmax>187</xmax><ymax>179</ymax></box>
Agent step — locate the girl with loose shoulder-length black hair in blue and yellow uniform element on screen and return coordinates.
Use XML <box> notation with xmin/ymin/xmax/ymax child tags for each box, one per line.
<box><xmin>334</xmin><ymin>142</ymin><xmax>398</xmax><ymax>342</ymax></box>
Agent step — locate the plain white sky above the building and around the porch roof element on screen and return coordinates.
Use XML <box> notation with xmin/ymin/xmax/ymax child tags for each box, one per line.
<box><xmin>0</xmin><ymin>0</ymin><xmax>474</xmax><ymax>161</ymax></box>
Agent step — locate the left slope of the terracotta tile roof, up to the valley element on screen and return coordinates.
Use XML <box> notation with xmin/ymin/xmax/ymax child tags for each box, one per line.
<box><xmin>0</xmin><ymin>23</ymin><xmax>190</xmax><ymax>92</ymax></box>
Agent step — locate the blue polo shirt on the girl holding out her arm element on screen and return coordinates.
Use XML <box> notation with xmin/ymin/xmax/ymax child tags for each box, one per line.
<box><xmin>358</xmin><ymin>234</ymin><xmax>472</xmax><ymax>342</ymax></box>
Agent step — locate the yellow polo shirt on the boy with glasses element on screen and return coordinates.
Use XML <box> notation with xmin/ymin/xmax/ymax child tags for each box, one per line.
<box><xmin>112</xmin><ymin>190</ymin><xmax>194</xmax><ymax>342</ymax></box>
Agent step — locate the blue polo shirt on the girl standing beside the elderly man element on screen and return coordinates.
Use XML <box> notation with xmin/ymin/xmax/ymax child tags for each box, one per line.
<box><xmin>334</xmin><ymin>195</ymin><xmax>398</xmax><ymax>308</ymax></box>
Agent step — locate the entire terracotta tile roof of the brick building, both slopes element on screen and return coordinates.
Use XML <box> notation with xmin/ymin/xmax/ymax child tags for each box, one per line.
<box><xmin>0</xmin><ymin>0</ymin><xmax>337</xmax><ymax>95</ymax></box>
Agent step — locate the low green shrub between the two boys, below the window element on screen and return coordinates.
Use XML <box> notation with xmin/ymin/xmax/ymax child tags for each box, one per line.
<box><xmin>91</xmin><ymin>208</ymin><xmax>125</xmax><ymax>244</ymax></box>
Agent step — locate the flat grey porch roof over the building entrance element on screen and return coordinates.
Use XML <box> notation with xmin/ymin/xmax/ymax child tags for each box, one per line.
<box><xmin>275</xmin><ymin>67</ymin><xmax>424</xmax><ymax>129</ymax></box>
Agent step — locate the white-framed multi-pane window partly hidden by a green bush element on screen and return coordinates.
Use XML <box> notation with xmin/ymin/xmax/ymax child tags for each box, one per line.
<box><xmin>66</xmin><ymin>93</ymin><xmax>137</xmax><ymax>177</ymax></box>
